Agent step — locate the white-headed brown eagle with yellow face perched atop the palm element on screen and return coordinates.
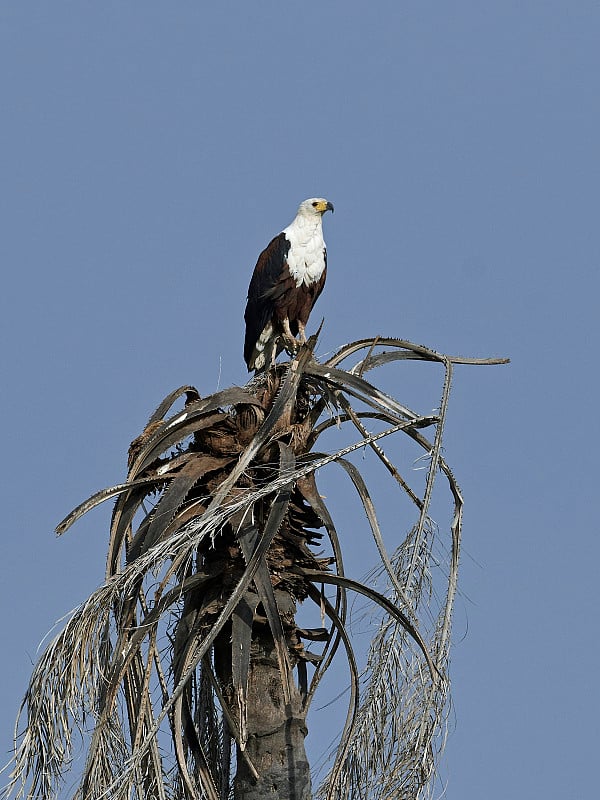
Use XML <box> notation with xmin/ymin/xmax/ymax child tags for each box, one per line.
<box><xmin>244</xmin><ymin>197</ymin><xmax>333</xmax><ymax>372</ymax></box>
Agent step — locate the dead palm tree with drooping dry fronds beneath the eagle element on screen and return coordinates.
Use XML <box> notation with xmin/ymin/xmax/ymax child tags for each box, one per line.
<box><xmin>2</xmin><ymin>337</ymin><xmax>500</xmax><ymax>800</ymax></box>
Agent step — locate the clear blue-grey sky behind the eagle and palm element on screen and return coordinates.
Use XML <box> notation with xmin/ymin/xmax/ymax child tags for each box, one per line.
<box><xmin>0</xmin><ymin>0</ymin><xmax>600</xmax><ymax>800</ymax></box>
